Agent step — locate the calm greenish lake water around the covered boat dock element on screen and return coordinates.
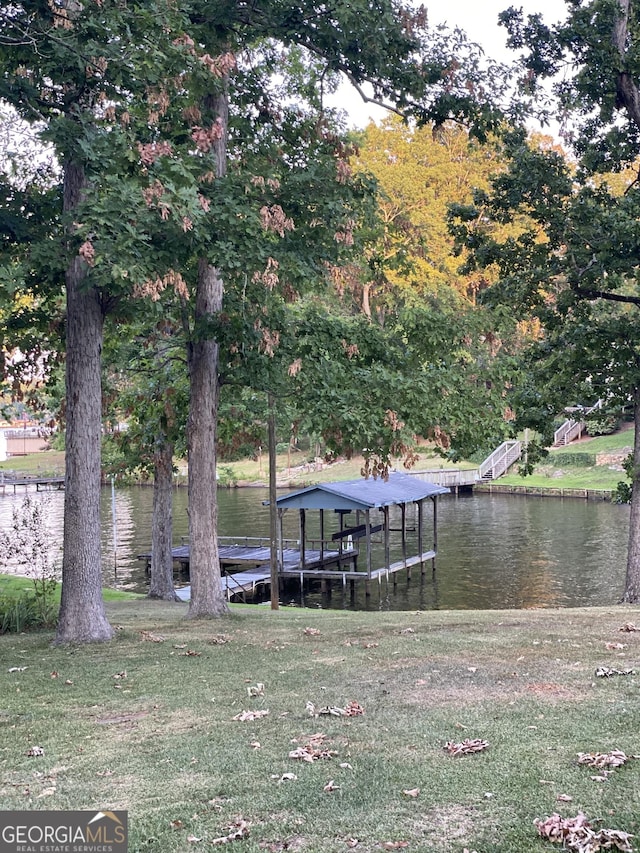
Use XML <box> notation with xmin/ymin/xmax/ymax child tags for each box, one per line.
<box><xmin>0</xmin><ymin>487</ymin><xmax>629</xmax><ymax>610</ymax></box>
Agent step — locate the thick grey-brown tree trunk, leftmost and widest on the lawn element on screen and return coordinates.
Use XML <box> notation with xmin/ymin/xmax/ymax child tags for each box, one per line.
<box><xmin>56</xmin><ymin>163</ymin><xmax>113</xmax><ymax>643</ymax></box>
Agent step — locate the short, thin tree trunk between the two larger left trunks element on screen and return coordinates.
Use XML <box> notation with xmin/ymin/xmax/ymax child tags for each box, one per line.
<box><xmin>149</xmin><ymin>435</ymin><xmax>179</xmax><ymax>601</ymax></box>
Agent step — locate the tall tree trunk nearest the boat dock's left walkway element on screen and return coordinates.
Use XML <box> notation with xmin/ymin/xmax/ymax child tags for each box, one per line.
<box><xmin>188</xmin><ymin>259</ymin><xmax>229</xmax><ymax>616</ymax></box>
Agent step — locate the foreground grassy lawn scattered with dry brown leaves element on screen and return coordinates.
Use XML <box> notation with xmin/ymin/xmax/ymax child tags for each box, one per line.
<box><xmin>0</xmin><ymin>599</ymin><xmax>640</xmax><ymax>853</ymax></box>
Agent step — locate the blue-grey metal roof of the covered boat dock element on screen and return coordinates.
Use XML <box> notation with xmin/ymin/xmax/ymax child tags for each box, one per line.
<box><xmin>276</xmin><ymin>473</ymin><xmax>449</xmax><ymax>510</ymax></box>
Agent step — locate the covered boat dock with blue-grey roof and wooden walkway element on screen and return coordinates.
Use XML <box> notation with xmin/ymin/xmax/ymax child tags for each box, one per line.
<box><xmin>139</xmin><ymin>473</ymin><xmax>450</xmax><ymax>598</ymax></box>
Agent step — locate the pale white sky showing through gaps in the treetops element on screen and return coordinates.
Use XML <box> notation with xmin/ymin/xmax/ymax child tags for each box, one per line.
<box><xmin>338</xmin><ymin>0</ymin><xmax>566</xmax><ymax>127</ymax></box>
